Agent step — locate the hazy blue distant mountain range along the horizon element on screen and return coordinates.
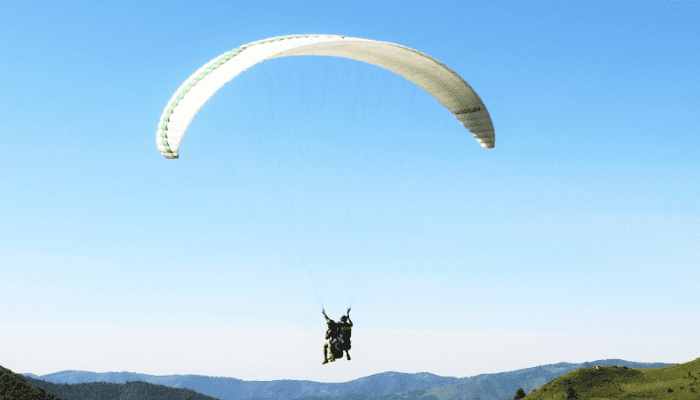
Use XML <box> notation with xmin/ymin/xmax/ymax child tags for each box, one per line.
<box><xmin>32</xmin><ymin>360</ymin><xmax>668</xmax><ymax>400</ymax></box>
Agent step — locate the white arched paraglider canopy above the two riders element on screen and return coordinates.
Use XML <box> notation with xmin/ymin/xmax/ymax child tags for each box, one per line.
<box><xmin>156</xmin><ymin>34</ymin><xmax>495</xmax><ymax>159</ymax></box>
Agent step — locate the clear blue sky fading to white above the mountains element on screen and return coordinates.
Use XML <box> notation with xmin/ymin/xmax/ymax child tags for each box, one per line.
<box><xmin>0</xmin><ymin>0</ymin><xmax>700</xmax><ymax>381</ymax></box>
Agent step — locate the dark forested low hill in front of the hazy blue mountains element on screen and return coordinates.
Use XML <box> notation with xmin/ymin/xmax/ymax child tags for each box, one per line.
<box><xmin>27</xmin><ymin>379</ymin><xmax>216</xmax><ymax>400</ymax></box>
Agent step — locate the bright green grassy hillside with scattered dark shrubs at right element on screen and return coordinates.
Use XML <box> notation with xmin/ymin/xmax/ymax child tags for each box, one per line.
<box><xmin>525</xmin><ymin>358</ymin><xmax>700</xmax><ymax>400</ymax></box>
